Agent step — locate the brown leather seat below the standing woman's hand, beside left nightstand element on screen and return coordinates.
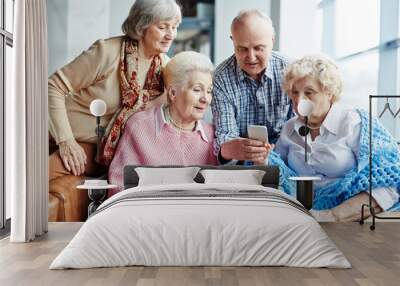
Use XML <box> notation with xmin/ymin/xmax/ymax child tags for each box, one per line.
<box><xmin>48</xmin><ymin>175</ymin><xmax>89</xmax><ymax>221</ymax></box>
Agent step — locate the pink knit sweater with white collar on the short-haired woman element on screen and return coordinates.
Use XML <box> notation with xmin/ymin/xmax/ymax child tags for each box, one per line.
<box><xmin>108</xmin><ymin>104</ymin><xmax>217</xmax><ymax>196</ymax></box>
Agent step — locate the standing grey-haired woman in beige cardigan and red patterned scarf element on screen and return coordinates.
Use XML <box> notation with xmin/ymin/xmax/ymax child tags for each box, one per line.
<box><xmin>49</xmin><ymin>0</ymin><xmax>181</xmax><ymax>221</ymax></box>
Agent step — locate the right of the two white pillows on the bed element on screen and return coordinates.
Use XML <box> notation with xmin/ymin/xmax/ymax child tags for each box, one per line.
<box><xmin>200</xmin><ymin>169</ymin><xmax>265</xmax><ymax>185</ymax></box>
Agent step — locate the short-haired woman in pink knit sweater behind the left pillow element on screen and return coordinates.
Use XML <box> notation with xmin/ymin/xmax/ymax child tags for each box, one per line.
<box><xmin>108</xmin><ymin>52</ymin><xmax>217</xmax><ymax>196</ymax></box>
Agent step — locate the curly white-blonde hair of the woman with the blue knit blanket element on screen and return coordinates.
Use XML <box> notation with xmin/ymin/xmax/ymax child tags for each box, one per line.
<box><xmin>283</xmin><ymin>54</ymin><xmax>343</xmax><ymax>102</ymax></box>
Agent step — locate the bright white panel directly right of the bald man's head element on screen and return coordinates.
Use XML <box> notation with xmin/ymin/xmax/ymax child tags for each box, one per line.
<box><xmin>278</xmin><ymin>0</ymin><xmax>321</xmax><ymax>58</ymax></box>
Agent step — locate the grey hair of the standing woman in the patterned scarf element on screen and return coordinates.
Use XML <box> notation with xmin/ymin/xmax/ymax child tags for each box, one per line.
<box><xmin>122</xmin><ymin>0</ymin><xmax>182</xmax><ymax>40</ymax></box>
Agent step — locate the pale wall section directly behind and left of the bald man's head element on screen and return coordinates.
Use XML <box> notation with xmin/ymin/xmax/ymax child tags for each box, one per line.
<box><xmin>214</xmin><ymin>0</ymin><xmax>271</xmax><ymax>65</ymax></box>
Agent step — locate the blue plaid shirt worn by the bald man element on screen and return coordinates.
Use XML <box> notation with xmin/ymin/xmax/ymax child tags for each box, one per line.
<box><xmin>211</xmin><ymin>52</ymin><xmax>294</xmax><ymax>154</ymax></box>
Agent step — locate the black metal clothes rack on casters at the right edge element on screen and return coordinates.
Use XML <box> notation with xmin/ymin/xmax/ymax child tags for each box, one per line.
<box><xmin>360</xmin><ymin>95</ymin><xmax>400</xmax><ymax>230</ymax></box>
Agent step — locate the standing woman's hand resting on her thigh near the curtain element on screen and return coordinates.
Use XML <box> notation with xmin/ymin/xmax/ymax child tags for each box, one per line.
<box><xmin>58</xmin><ymin>139</ymin><xmax>87</xmax><ymax>176</ymax></box>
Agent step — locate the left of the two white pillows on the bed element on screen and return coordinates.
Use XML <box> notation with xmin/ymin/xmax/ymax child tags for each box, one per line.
<box><xmin>135</xmin><ymin>167</ymin><xmax>200</xmax><ymax>186</ymax></box>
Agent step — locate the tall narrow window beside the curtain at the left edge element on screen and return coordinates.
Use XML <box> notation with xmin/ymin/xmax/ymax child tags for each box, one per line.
<box><xmin>0</xmin><ymin>0</ymin><xmax>14</xmax><ymax>233</ymax></box>
